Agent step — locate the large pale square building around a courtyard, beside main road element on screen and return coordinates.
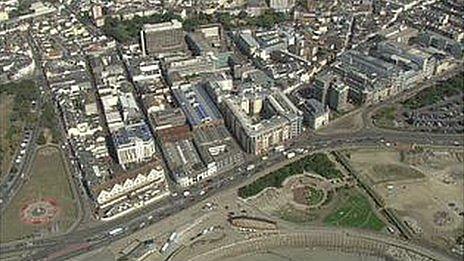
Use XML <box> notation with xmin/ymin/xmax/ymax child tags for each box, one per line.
<box><xmin>224</xmin><ymin>90</ymin><xmax>303</xmax><ymax>155</ymax></box>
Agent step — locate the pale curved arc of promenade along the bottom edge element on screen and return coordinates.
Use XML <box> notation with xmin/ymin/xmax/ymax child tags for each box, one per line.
<box><xmin>179</xmin><ymin>227</ymin><xmax>453</xmax><ymax>261</ymax></box>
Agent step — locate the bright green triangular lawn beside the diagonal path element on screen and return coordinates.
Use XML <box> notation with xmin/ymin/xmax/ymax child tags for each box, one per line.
<box><xmin>324</xmin><ymin>190</ymin><xmax>385</xmax><ymax>231</ymax></box>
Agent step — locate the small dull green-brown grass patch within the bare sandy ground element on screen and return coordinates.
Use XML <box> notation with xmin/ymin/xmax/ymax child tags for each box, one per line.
<box><xmin>371</xmin><ymin>164</ymin><xmax>424</xmax><ymax>183</ymax></box>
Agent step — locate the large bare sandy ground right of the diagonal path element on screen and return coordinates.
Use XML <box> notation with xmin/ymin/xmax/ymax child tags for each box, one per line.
<box><xmin>349</xmin><ymin>149</ymin><xmax>464</xmax><ymax>248</ymax></box>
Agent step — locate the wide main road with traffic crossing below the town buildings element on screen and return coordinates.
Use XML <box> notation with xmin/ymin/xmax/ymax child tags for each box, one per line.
<box><xmin>0</xmin><ymin>125</ymin><xmax>463</xmax><ymax>260</ymax></box>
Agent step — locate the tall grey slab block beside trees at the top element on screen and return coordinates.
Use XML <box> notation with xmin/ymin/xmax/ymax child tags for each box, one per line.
<box><xmin>140</xmin><ymin>20</ymin><xmax>184</xmax><ymax>54</ymax></box>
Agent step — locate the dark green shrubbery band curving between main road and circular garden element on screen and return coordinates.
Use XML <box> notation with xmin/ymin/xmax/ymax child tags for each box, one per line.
<box><xmin>238</xmin><ymin>153</ymin><xmax>343</xmax><ymax>198</ymax></box>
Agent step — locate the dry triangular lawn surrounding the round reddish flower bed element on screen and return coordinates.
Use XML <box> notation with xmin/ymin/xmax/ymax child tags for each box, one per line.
<box><xmin>0</xmin><ymin>146</ymin><xmax>78</xmax><ymax>242</ymax></box>
